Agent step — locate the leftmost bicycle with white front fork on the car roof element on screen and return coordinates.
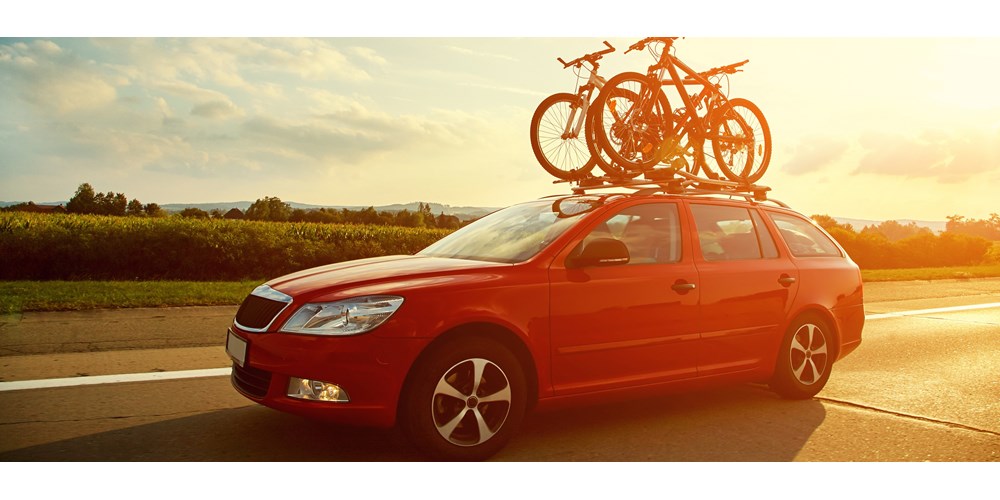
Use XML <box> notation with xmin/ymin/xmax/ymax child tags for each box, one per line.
<box><xmin>529</xmin><ymin>41</ymin><xmax>664</xmax><ymax>181</ymax></box>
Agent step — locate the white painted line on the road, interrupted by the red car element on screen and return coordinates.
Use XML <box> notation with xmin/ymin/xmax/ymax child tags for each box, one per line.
<box><xmin>0</xmin><ymin>302</ymin><xmax>1000</xmax><ymax>392</ymax></box>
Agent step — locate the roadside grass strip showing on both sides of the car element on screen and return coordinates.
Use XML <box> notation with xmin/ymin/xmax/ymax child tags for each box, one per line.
<box><xmin>0</xmin><ymin>264</ymin><xmax>1000</xmax><ymax>314</ymax></box>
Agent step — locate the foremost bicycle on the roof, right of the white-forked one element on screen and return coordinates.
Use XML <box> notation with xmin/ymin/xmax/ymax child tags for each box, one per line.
<box><xmin>587</xmin><ymin>37</ymin><xmax>771</xmax><ymax>184</ymax></box>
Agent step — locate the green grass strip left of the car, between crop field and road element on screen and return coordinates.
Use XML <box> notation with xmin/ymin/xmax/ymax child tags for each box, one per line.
<box><xmin>0</xmin><ymin>281</ymin><xmax>261</xmax><ymax>314</ymax></box>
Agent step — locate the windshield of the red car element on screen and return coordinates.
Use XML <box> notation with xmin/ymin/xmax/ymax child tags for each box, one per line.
<box><xmin>417</xmin><ymin>196</ymin><xmax>602</xmax><ymax>263</ymax></box>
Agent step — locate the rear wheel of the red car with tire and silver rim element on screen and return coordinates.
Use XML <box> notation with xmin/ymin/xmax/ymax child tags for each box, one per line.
<box><xmin>770</xmin><ymin>315</ymin><xmax>835</xmax><ymax>399</ymax></box>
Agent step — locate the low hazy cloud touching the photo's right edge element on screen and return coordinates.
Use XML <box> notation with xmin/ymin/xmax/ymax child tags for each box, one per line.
<box><xmin>855</xmin><ymin>130</ymin><xmax>1000</xmax><ymax>183</ymax></box>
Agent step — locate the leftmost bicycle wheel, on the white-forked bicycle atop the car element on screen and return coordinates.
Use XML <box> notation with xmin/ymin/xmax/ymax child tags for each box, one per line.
<box><xmin>530</xmin><ymin>93</ymin><xmax>594</xmax><ymax>181</ymax></box>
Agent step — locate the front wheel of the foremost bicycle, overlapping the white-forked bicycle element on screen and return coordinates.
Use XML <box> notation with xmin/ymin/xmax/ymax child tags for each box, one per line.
<box><xmin>587</xmin><ymin>72</ymin><xmax>673</xmax><ymax>172</ymax></box>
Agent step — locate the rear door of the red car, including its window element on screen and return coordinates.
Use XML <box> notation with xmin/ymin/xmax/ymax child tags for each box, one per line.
<box><xmin>689</xmin><ymin>201</ymin><xmax>798</xmax><ymax>376</ymax></box>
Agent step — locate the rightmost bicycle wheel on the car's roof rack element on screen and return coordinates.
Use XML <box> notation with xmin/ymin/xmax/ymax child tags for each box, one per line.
<box><xmin>709</xmin><ymin>98</ymin><xmax>771</xmax><ymax>184</ymax></box>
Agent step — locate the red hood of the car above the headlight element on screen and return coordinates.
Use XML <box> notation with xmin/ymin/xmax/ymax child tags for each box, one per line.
<box><xmin>267</xmin><ymin>255</ymin><xmax>511</xmax><ymax>297</ymax></box>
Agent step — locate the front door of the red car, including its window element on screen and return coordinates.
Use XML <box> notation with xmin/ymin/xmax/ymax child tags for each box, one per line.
<box><xmin>550</xmin><ymin>202</ymin><xmax>700</xmax><ymax>395</ymax></box>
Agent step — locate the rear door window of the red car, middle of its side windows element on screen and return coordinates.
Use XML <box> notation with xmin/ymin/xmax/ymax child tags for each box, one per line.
<box><xmin>691</xmin><ymin>203</ymin><xmax>778</xmax><ymax>261</ymax></box>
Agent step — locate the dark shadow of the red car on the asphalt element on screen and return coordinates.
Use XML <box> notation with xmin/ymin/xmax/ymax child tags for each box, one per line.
<box><xmin>0</xmin><ymin>385</ymin><xmax>825</xmax><ymax>462</ymax></box>
